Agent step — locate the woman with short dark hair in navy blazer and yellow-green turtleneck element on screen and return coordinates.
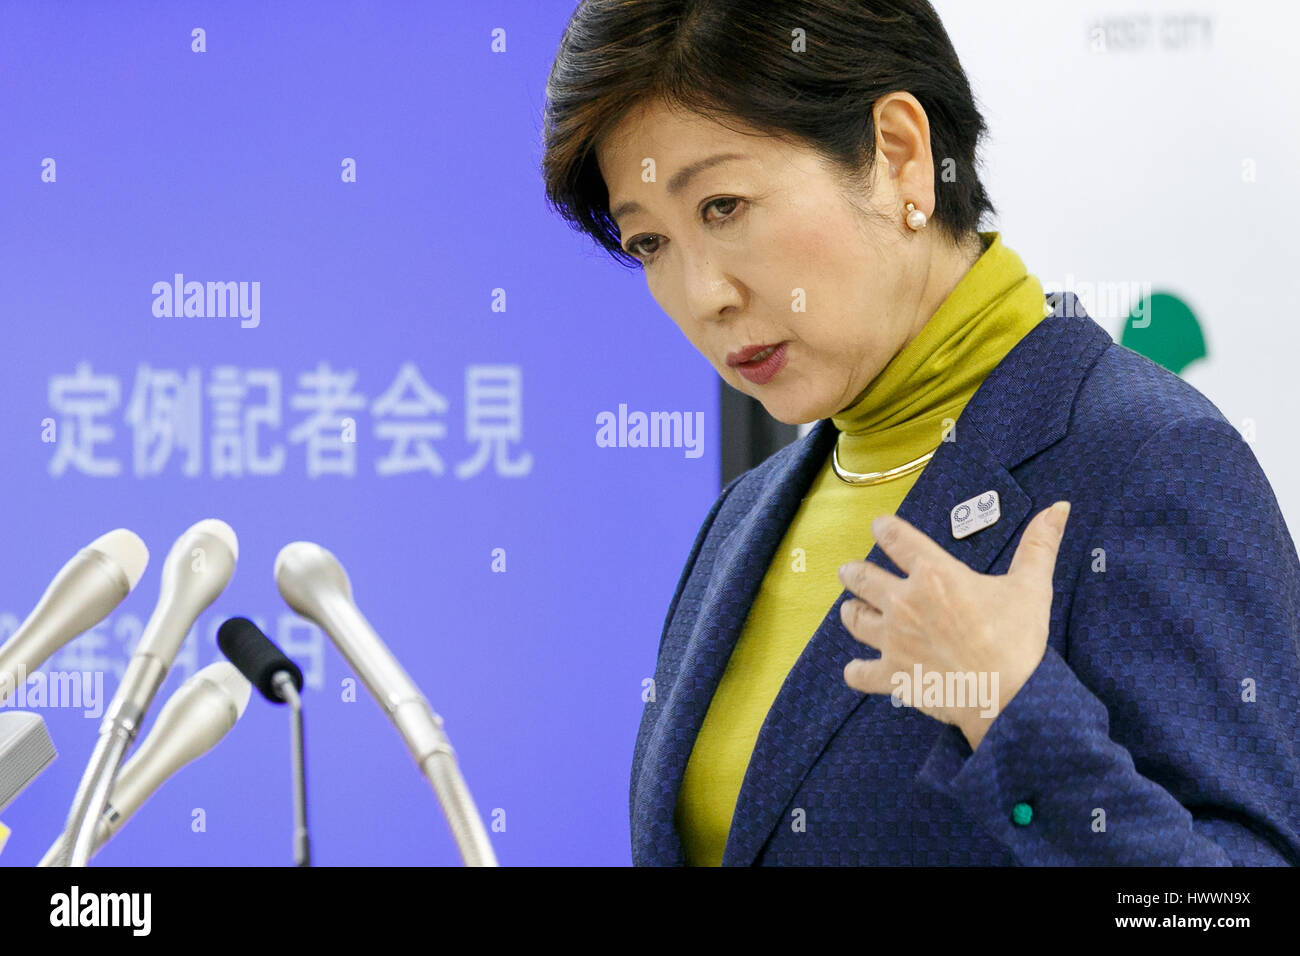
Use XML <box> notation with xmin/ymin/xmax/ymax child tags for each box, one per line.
<box><xmin>543</xmin><ymin>0</ymin><xmax>1300</xmax><ymax>865</ymax></box>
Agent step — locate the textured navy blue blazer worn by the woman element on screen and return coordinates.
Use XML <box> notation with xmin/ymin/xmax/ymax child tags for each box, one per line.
<box><xmin>631</xmin><ymin>293</ymin><xmax>1300</xmax><ymax>866</ymax></box>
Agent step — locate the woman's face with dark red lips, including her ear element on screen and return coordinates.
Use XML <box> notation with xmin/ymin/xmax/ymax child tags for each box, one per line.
<box><xmin>597</xmin><ymin>92</ymin><xmax>979</xmax><ymax>424</ymax></box>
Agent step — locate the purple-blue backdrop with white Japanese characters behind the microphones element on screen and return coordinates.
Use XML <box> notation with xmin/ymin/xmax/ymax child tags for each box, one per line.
<box><xmin>0</xmin><ymin>0</ymin><xmax>719</xmax><ymax>866</ymax></box>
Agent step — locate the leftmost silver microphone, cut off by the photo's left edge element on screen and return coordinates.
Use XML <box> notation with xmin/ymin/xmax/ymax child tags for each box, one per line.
<box><xmin>0</xmin><ymin>528</ymin><xmax>150</xmax><ymax>704</ymax></box>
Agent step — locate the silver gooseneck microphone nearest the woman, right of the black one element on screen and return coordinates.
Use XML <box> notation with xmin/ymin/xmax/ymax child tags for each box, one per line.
<box><xmin>276</xmin><ymin>541</ymin><xmax>497</xmax><ymax>866</ymax></box>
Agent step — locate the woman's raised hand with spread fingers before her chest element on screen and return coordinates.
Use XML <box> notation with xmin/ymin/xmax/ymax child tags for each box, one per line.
<box><xmin>840</xmin><ymin>502</ymin><xmax>1069</xmax><ymax>750</ymax></box>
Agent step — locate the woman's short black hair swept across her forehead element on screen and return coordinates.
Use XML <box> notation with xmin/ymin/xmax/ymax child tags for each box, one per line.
<box><xmin>541</xmin><ymin>0</ymin><xmax>996</xmax><ymax>267</ymax></box>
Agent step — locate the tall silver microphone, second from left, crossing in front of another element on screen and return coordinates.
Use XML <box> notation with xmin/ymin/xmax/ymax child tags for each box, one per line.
<box><xmin>64</xmin><ymin>518</ymin><xmax>239</xmax><ymax>866</ymax></box>
